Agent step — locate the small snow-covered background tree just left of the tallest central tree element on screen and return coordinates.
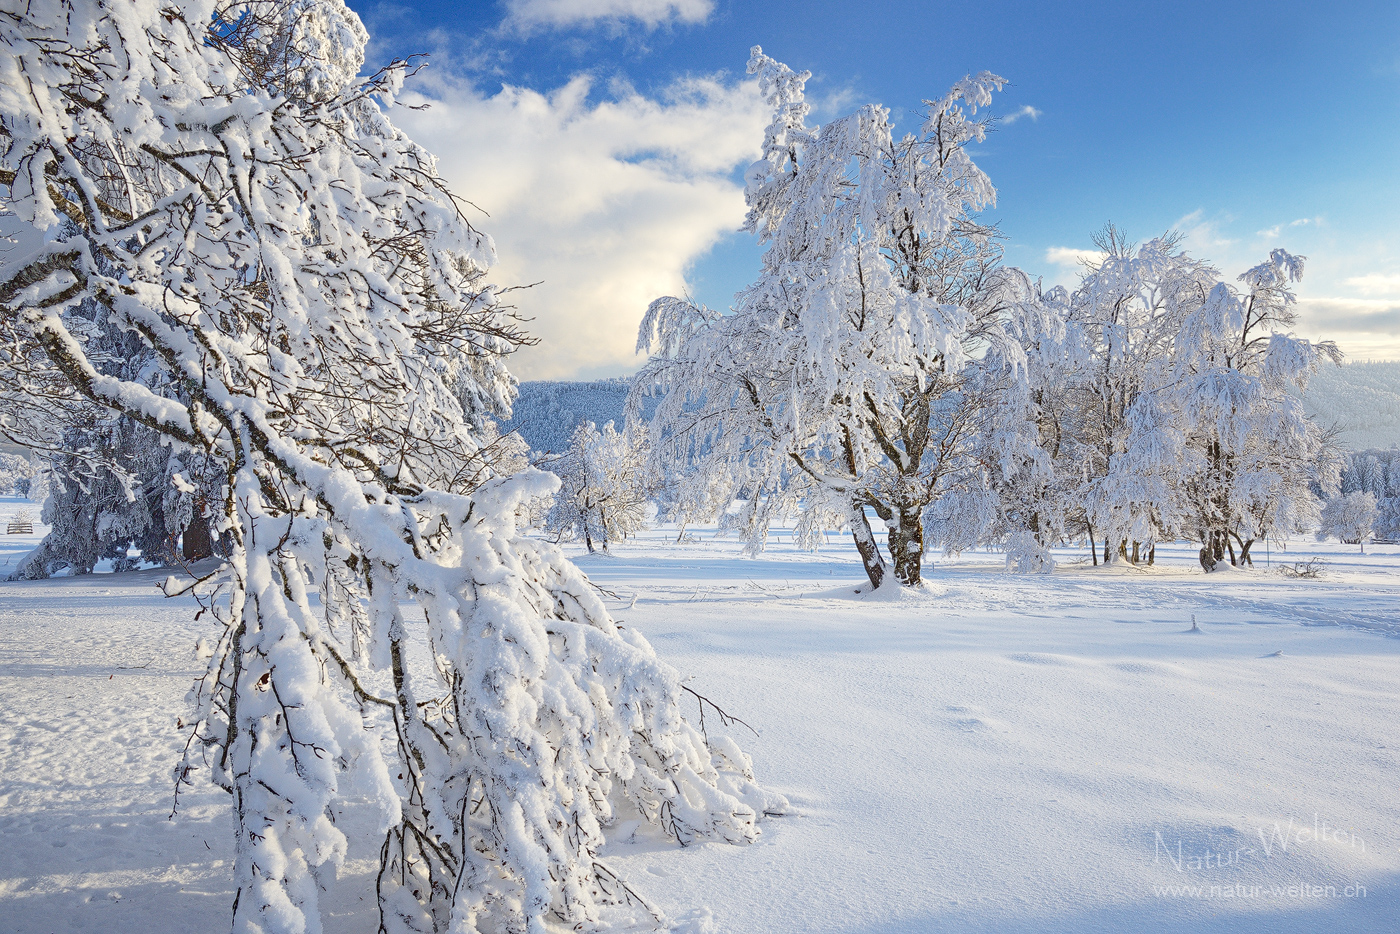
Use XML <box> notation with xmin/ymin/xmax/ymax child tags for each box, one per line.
<box><xmin>540</xmin><ymin>421</ymin><xmax>652</xmax><ymax>552</ymax></box>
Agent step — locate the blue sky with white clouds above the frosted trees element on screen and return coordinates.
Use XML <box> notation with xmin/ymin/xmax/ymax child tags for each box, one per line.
<box><xmin>350</xmin><ymin>0</ymin><xmax>1400</xmax><ymax>378</ymax></box>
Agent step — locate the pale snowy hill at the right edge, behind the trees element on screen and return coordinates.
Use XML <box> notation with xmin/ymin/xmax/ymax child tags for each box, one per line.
<box><xmin>1303</xmin><ymin>360</ymin><xmax>1400</xmax><ymax>451</ymax></box>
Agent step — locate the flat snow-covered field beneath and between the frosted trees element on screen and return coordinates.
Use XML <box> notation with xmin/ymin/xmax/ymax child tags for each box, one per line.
<box><xmin>0</xmin><ymin>500</ymin><xmax>1400</xmax><ymax>934</ymax></box>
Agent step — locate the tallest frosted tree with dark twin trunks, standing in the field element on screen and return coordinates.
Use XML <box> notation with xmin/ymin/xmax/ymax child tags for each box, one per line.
<box><xmin>633</xmin><ymin>46</ymin><xmax>1033</xmax><ymax>587</ymax></box>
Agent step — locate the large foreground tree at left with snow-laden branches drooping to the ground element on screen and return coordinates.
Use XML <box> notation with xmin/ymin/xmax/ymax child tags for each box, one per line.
<box><xmin>0</xmin><ymin>0</ymin><xmax>784</xmax><ymax>934</ymax></box>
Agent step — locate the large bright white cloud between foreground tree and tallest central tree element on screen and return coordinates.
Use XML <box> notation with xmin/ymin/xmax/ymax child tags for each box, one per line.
<box><xmin>395</xmin><ymin>77</ymin><xmax>769</xmax><ymax>379</ymax></box>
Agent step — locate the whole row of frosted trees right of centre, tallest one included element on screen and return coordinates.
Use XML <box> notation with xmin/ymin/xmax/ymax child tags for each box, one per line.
<box><xmin>630</xmin><ymin>48</ymin><xmax>1340</xmax><ymax>587</ymax></box>
